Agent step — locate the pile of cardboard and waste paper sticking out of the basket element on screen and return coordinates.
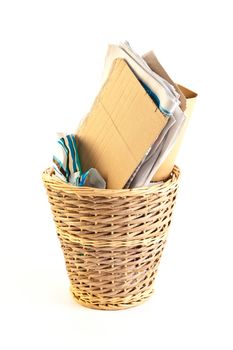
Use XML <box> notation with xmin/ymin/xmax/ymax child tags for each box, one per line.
<box><xmin>50</xmin><ymin>42</ymin><xmax>196</xmax><ymax>189</ymax></box>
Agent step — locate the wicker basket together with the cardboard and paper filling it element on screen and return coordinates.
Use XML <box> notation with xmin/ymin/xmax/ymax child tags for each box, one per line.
<box><xmin>43</xmin><ymin>43</ymin><xmax>196</xmax><ymax>310</ymax></box>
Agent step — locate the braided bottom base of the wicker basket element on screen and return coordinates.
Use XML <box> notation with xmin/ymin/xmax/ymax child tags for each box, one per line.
<box><xmin>70</xmin><ymin>286</ymin><xmax>154</xmax><ymax>311</ymax></box>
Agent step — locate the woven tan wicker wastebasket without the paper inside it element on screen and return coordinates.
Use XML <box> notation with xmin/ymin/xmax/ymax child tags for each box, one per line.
<box><xmin>43</xmin><ymin>166</ymin><xmax>180</xmax><ymax>310</ymax></box>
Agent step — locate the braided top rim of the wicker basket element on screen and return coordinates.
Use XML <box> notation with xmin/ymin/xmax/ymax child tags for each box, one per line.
<box><xmin>42</xmin><ymin>165</ymin><xmax>180</xmax><ymax>197</ymax></box>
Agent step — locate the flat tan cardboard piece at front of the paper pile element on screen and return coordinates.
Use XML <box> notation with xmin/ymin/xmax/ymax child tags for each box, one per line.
<box><xmin>76</xmin><ymin>59</ymin><xmax>168</xmax><ymax>189</ymax></box>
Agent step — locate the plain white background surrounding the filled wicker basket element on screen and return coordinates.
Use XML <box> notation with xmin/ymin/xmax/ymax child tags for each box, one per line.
<box><xmin>0</xmin><ymin>0</ymin><xmax>233</xmax><ymax>350</ymax></box>
